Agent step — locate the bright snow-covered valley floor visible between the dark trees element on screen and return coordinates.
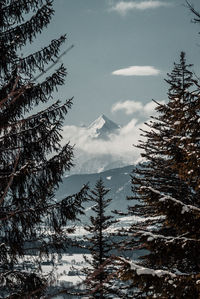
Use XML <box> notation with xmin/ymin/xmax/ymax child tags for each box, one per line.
<box><xmin>19</xmin><ymin>216</ymin><xmax>150</xmax><ymax>299</ymax></box>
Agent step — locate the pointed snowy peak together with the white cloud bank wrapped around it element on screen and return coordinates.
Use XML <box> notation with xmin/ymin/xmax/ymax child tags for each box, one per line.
<box><xmin>63</xmin><ymin>116</ymin><xmax>144</xmax><ymax>173</ymax></box>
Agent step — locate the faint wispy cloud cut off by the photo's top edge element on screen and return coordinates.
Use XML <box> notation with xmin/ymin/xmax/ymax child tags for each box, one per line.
<box><xmin>110</xmin><ymin>0</ymin><xmax>170</xmax><ymax>15</ymax></box>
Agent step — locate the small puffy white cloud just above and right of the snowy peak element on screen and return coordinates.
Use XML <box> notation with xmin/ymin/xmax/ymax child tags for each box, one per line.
<box><xmin>112</xmin><ymin>101</ymin><xmax>164</xmax><ymax>117</ymax></box>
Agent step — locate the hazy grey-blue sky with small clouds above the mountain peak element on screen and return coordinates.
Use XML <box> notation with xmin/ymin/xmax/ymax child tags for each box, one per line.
<box><xmin>31</xmin><ymin>0</ymin><xmax>200</xmax><ymax>125</ymax></box>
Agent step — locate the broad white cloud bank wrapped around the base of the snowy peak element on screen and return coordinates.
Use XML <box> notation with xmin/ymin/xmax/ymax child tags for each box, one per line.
<box><xmin>62</xmin><ymin>119</ymin><xmax>144</xmax><ymax>164</ymax></box>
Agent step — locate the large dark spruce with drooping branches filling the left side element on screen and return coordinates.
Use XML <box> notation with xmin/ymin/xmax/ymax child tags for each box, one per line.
<box><xmin>0</xmin><ymin>0</ymin><xmax>86</xmax><ymax>298</ymax></box>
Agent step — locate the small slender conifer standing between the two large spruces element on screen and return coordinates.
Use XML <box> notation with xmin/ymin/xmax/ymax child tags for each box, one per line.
<box><xmin>79</xmin><ymin>179</ymin><xmax>127</xmax><ymax>299</ymax></box>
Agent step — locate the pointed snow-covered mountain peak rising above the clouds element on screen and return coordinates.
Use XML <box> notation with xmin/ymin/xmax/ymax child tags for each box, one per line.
<box><xmin>88</xmin><ymin>114</ymin><xmax>120</xmax><ymax>139</ymax></box>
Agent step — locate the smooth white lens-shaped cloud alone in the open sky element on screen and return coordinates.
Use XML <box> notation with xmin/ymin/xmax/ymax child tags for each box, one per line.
<box><xmin>112</xmin><ymin>66</ymin><xmax>160</xmax><ymax>76</ymax></box>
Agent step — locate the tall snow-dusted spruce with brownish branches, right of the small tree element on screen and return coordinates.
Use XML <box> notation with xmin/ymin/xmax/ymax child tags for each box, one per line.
<box><xmin>118</xmin><ymin>52</ymin><xmax>200</xmax><ymax>298</ymax></box>
